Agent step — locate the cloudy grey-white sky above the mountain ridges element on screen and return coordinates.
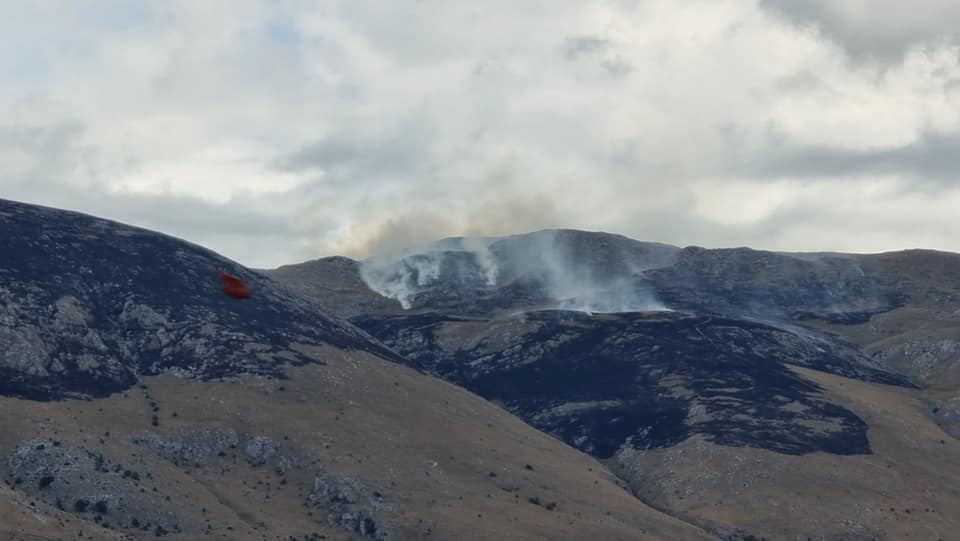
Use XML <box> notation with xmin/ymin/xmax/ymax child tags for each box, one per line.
<box><xmin>0</xmin><ymin>0</ymin><xmax>960</xmax><ymax>268</ymax></box>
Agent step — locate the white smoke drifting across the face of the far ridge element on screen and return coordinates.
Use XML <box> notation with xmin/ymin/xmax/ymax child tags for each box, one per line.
<box><xmin>361</xmin><ymin>230</ymin><xmax>676</xmax><ymax>313</ymax></box>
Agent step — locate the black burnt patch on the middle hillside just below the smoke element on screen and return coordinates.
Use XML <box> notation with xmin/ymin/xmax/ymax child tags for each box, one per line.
<box><xmin>354</xmin><ymin>311</ymin><xmax>905</xmax><ymax>458</ymax></box>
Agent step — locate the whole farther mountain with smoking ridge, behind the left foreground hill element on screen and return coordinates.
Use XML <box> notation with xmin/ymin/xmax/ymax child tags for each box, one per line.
<box><xmin>266</xmin><ymin>230</ymin><xmax>960</xmax><ymax>539</ymax></box>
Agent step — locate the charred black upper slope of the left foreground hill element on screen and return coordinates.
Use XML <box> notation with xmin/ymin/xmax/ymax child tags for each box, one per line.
<box><xmin>0</xmin><ymin>200</ymin><xmax>396</xmax><ymax>400</ymax></box>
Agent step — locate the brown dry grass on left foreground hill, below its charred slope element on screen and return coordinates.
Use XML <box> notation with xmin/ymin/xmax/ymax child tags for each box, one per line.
<box><xmin>0</xmin><ymin>348</ymin><xmax>707</xmax><ymax>540</ymax></box>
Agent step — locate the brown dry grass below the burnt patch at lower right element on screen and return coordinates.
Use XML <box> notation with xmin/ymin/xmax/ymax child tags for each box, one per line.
<box><xmin>620</xmin><ymin>368</ymin><xmax>960</xmax><ymax>540</ymax></box>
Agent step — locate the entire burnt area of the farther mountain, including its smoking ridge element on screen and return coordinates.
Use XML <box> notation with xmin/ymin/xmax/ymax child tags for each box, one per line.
<box><xmin>268</xmin><ymin>230</ymin><xmax>924</xmax><ymax>458</ymax></box>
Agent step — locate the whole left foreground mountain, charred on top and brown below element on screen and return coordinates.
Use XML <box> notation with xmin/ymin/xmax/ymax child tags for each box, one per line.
<box><xmin>0</xmin><ymin>200</ymin><xmax>712</xmax><ymax>541</ymax></box>
